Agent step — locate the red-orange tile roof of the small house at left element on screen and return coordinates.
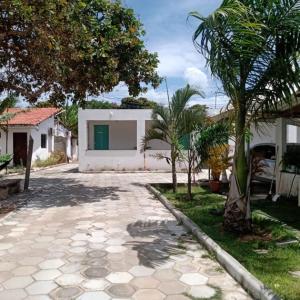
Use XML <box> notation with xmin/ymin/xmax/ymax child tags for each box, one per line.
<box><xmin>3</xmin><ymin>107</ymin><xmax>60</xmax><ymax>126</ymax></box>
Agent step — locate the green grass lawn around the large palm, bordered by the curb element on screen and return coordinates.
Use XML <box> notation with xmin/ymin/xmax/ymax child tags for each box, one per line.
<box><xmin>156</xmin><ymin>185</ymin><xmax>300</xmax><ymax>300</ymax></box>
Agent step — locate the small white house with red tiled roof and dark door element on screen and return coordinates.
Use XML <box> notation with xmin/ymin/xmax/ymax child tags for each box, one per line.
<box><xmin>0</xmin><ymin>108</ymin><xmax>72</xmax><ymax>165</ymax></box>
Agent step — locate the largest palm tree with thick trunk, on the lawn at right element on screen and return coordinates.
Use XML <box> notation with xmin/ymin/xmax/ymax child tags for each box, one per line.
<box><xmin>190</xmin><ymin>0</ymin><xmax>300</xmax><ymax>232</ymax></box>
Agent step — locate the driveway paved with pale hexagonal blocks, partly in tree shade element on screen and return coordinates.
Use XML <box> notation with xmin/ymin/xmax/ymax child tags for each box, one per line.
<box><xmin>0</xmin><ymin>165</ymin><xmax>250</xmax><ymax>300</ymax></box>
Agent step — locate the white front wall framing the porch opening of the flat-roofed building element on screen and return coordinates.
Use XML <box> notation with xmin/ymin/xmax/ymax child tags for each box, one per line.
<box><xmin>78</xmin><ymin>109</ymin><xmax>176</xmax><ymax>172</ymax></box>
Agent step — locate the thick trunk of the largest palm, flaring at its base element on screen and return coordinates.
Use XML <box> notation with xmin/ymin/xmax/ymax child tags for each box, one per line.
<box><xmin>223</xmin><ymin>106</ymin><xmax>251</xmax><ymax>233</ymax></box>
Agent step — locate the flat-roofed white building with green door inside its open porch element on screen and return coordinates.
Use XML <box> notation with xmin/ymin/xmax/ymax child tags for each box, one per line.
<box><xmin>78</xmin><ymin>109</ymin><xmax>175</xmax><ymax>172</ymax></box>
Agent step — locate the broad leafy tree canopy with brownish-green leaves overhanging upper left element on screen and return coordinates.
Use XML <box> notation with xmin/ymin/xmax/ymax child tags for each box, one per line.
<box><xmin>0</xmin><ymin>0</ymin><xmax>160</xmax><ymax>103</ymax></box>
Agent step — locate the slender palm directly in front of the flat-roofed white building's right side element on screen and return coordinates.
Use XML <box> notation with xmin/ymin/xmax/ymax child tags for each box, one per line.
<box><xmin>143</xmin><ymin>85</ymin><xmax>202</xmax><ymax>193</ymax></box>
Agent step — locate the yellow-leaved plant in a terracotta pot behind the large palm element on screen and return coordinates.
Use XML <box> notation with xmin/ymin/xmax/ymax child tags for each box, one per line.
<box><xmin>207</xmin><ymin>145</ymin><xmax>229</xmax><ymax>193</ymax></box>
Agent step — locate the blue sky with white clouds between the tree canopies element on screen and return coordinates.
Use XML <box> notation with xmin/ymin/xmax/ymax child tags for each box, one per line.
<box><xmin>103</xmin><ymin>0</ymin><xmax>227</xmax><ymax>113</ymax></box>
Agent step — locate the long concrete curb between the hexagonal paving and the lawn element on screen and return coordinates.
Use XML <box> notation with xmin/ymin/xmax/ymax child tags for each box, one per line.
<box><xmin>146</xmin><ymin>184</ymin><xmax>281</xmax><ymax>300</ymax></box>
